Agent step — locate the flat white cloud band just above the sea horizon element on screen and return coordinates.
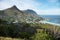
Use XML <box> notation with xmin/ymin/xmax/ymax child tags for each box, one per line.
<box><xmin>38</xmin><ymin>9</ymin><xmax>60</xmax><ymax>15</ymax></box>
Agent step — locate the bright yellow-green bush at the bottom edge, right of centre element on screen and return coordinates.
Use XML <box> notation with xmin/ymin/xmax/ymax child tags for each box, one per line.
<box><xmin>34</xmin><ymin>29</ymin><xmax>52</xmax><ymax>40</ymax></box>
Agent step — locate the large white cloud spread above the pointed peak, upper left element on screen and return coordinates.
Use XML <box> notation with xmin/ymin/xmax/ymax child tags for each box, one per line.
<box><xmin>0</xmin><ymin>0</ymin><xmax>42</xmax><ymax>10</ymax></box>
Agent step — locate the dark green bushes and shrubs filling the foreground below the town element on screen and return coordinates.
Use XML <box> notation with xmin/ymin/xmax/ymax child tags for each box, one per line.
<box><xmin>0</xmin><ymin>19</ymin><xmax>57</xmax><ymax>40</ymax></box>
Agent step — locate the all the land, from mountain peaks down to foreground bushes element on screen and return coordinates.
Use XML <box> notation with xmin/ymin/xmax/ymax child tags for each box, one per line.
<box><xmin>0</xmin><ymin>6</ymin><xmax>60</xmax><ymax>40</ymax></box>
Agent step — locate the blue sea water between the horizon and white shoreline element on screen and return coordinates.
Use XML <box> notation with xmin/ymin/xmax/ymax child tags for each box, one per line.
<box><xmin>40</xmin><ymin>15</ymin><xmax>60</xmax><ymax>24</ymax></box>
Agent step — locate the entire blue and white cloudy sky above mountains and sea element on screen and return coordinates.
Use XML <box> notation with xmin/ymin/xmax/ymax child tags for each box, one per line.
<box><xmin>0</xmin><ymin>0</ymin><xmax>60</xmax><ymax>15</ymax></box>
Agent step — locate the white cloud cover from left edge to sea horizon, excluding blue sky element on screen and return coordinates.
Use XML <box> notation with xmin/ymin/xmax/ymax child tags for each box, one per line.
<box><xmin>0</xmin><ymin>0</ymin><xmax>60</xmax><ymax>15</ymax></box>
